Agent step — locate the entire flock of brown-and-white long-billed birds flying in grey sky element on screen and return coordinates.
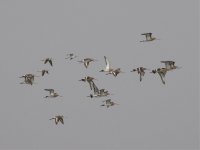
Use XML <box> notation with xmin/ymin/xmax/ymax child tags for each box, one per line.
<box><xmin>20</xmin><ymin>33</ymin><xmax>181</xmax><ymax>125</ymax></box>
